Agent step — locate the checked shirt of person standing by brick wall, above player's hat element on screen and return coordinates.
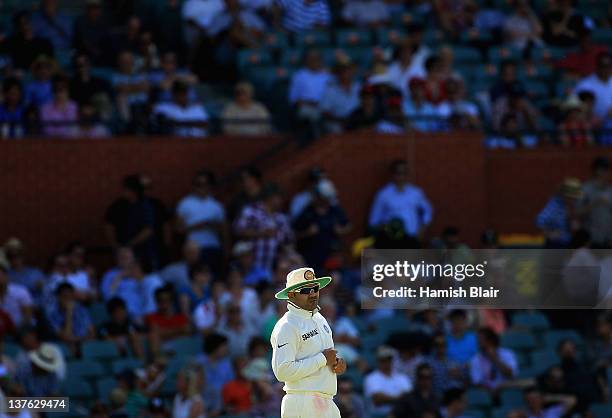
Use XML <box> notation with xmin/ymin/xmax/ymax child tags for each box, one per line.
<box><xmin>234</xmin><ymin>203</ymin><xmax>293</xmax><ymax>271</ymax></box>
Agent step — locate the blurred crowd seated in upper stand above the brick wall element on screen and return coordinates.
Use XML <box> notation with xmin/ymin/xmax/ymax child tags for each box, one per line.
<box><xmin>0</xmin><ymin>0</ymin><xmax>612</xmax><ymax>143</ymax></box>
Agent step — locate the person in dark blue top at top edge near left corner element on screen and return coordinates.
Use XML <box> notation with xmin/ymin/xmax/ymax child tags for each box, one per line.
<box><xmin>32</xmin><ymin>0</ymin><xmax>73</xmax><ymax>50</ymax></box>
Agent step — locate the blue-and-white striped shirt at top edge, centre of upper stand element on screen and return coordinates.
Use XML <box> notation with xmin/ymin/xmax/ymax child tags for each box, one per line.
<box><xmin>277</xmin><ymin>0</ymin><xmax>331</xmax><ymax>32</ymax></box>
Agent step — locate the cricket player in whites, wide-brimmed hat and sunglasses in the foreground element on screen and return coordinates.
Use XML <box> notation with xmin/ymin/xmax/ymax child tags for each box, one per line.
<box><xmin>270</xmin><ymin>268</ymin><xmax>346</xmax><ymax>418</ymax></box>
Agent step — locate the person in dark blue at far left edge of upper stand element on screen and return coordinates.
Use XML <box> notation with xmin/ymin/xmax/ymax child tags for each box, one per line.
<box><xmin>0</xmin><ymin>78</ymin><xmax>25</xmax><ymax>139</ymax></box>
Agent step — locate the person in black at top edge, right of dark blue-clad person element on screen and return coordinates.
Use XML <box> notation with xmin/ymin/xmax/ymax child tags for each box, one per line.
<box><xmin>72</xmin><ymin>0</ymin><xmax>109</xmax><ymax>66</ymax></box>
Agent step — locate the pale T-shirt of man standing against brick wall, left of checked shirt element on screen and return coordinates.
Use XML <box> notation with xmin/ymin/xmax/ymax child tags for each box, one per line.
<box><xmin>176</xmin><ymin>195</ymin><xmax>225</xmax><ymax>248</ymax></box>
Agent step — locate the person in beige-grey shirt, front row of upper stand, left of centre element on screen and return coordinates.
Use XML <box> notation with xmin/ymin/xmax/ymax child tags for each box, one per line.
<box><xmin>221</xmin><ymin>82</ymin><xmax>271</xmax><ymax>135</ymax></box>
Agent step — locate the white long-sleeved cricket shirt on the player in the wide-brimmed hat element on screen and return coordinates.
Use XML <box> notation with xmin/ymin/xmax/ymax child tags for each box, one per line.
<box><xmin>270</xmin><ymin>303</ymin><xmax>337</xmax><ymax>397</ymax></box>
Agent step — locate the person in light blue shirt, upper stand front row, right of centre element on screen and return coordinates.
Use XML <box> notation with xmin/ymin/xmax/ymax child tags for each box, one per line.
<box><xmin>402</xmin><ymin>78</ymin><xmax>446</xmax><ymax>132</ymax></box>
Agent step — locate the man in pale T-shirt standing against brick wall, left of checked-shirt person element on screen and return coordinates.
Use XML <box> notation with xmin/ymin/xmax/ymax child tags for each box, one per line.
<box><xmin>176</xmin><ymin>170</ymin><xmax>225</xmax><ymax>276</ymax></box>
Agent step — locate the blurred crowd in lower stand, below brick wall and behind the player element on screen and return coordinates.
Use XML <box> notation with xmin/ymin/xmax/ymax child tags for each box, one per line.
<box><xmin>0</xmin><ymin>158</ymin><xmax>612</xmax><ymax>418</ymax></box>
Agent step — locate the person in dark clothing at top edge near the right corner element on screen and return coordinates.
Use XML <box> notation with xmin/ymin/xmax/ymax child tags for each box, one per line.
<box><xmin>542</xmin><ymin>0</ymin><xmax>585</xmax><ymax>47</ymax></box>
